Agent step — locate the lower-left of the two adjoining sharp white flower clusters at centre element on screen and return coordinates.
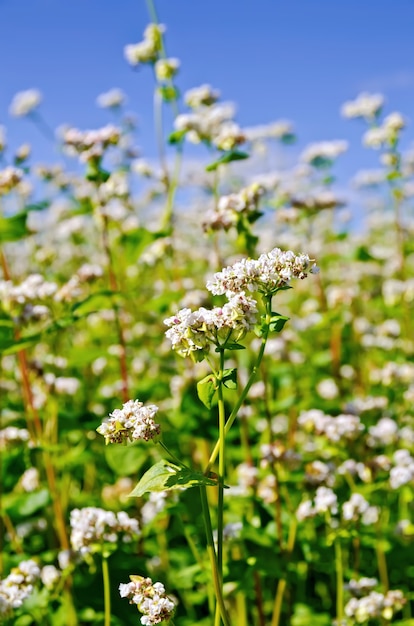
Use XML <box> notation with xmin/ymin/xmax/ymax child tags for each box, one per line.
<box><xmin>164</xmin><ymin>291</ymin><xmax>257</xmax><ymax>356</ymax></box>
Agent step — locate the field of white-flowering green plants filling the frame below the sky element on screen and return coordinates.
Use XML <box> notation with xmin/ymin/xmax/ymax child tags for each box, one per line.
<box><xmin>0</xmin><ymin>6</ymin><xmax>414</xmax><ymax>626</ymax></box>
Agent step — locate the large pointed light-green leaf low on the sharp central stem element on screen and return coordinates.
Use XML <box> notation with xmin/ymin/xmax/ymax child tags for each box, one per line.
<box><xmin>128</xmin><ymin>459</ymin><xmax>217</xmax><ymax>498</ymax></box>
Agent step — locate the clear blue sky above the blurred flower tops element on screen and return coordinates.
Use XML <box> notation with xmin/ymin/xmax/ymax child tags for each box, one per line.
<box><xmin>0</xmin><ymin>0</ymin><xmax>414</xmax><ymax>180</ymax></box>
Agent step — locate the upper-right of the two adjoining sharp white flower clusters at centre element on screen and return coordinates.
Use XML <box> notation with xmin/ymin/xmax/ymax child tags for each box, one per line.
<box><xmin>207</xmin><ymin>248</ymin><xmax>318</xmax><ymax>296</ymax></box>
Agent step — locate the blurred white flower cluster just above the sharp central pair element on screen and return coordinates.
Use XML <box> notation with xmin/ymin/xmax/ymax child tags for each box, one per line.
<box><xmin>203</xmin><ymin>183</ymin><xmax>264</xmax><ymax>230</ymax></box>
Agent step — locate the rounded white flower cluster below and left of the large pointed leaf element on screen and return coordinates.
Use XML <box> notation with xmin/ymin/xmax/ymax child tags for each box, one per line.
<box><xmin>70</xmin><ymin>506</ymin><xmax>139</xmax><ymax>554</ymax></box>
